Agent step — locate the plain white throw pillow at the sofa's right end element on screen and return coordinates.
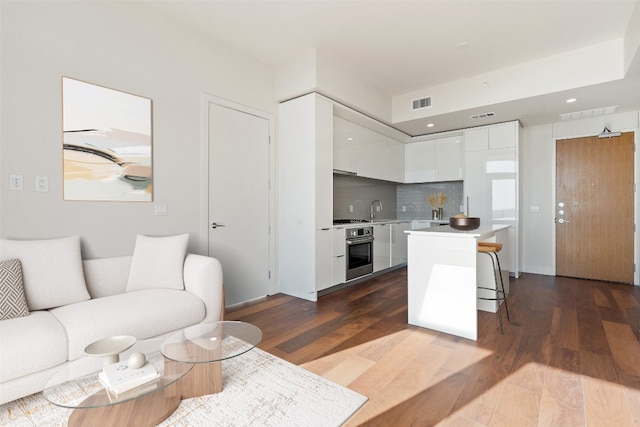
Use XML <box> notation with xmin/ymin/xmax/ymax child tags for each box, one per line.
<box><xmin>127</xmin><ymin>234</ymin><xmax>189</xmax><ymax>292</ymax></box>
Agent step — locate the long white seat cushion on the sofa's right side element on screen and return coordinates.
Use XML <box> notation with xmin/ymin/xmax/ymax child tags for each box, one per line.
<box><xmin>50</xmin><ymin>289</ymin><xmax>205</xmax><ymax>360</ymax></box>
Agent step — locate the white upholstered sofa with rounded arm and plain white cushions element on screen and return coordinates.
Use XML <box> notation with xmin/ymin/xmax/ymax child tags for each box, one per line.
<box><xmin>0</xmin><ymin>236</ymin><xmax>224</xmax><ymax>404</ymax></box>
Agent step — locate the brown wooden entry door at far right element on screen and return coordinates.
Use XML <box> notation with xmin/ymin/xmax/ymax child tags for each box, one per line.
<box><xmin>556</xmin><ymin>132</ymin><xmax>634</xmax><ymax>283</ymax></box>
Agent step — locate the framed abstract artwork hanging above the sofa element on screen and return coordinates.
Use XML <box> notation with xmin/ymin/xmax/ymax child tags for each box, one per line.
<box><xmin>62</xmin><ymin>77</ymin><xmax>153</xmax><ymax>202</ymax></box>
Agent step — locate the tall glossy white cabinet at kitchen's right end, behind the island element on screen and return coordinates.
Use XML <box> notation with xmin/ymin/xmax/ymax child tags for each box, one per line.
<box><xmin>464</xmin><ymin>122</ymin><xmax>520</xmax><ymax>277</ymax></box>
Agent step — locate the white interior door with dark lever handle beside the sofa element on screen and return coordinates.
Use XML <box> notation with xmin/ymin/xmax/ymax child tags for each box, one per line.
<box><xmin>208</xmin><ymin>102</ymin><xmax>271</xmax><ymax>306</ymax></box>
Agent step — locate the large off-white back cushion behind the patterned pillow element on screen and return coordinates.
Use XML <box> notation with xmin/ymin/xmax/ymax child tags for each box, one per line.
<box><xmin>0</xmin><ymin>236</ymin><xmax>90</xmax><ymax>311</ymax></box>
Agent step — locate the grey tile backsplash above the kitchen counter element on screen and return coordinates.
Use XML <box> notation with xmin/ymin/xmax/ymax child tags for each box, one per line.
<box><xmin>333</xmin><ymin>175</ymin><xmax>464</xmax><ymax>219</ymax></box>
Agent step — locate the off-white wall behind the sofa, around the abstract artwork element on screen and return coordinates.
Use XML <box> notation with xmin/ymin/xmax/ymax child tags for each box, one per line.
<box><xmin>0</xmin><ymin>1</ymin><xmax>277</xmax><ymax>258</ymax></box>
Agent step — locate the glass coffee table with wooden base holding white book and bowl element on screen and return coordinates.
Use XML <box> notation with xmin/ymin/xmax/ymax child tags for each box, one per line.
<box><xmin>43</xmin><ymin>340</ymin><xmax>194</xmax><ymax>426</ymax></box>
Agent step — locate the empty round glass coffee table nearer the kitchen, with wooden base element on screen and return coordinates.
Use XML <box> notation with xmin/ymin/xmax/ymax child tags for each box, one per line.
<box><xmin>160</xmin><ymin>321</ymin><xmax>262</xmax><ymax>399</ymax></box>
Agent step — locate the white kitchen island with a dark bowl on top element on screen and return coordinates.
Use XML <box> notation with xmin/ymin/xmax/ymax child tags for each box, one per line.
<box><xmin>406</xmin><ymin>225</ymin><xmax>509</xmax><ymax>340</ymax></box>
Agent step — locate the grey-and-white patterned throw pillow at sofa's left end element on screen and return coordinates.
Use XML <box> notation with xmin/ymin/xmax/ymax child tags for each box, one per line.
<box><xmin>0</xmin><ymin>259</ymin><xmax>29</xmax><ymax>320</ymax></box>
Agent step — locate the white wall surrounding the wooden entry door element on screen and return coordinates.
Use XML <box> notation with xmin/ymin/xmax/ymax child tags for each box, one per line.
<box><xmin>520</xmin><ymin>111</ymin><xmax>640</xmax><ymax>284</ymax></box>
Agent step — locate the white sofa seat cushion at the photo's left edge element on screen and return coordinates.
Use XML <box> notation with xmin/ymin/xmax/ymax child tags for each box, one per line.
<box><xmin>0</xmin><ymin>311</ymin><xmax>67</xmax><ymax>383</ymax></box>
